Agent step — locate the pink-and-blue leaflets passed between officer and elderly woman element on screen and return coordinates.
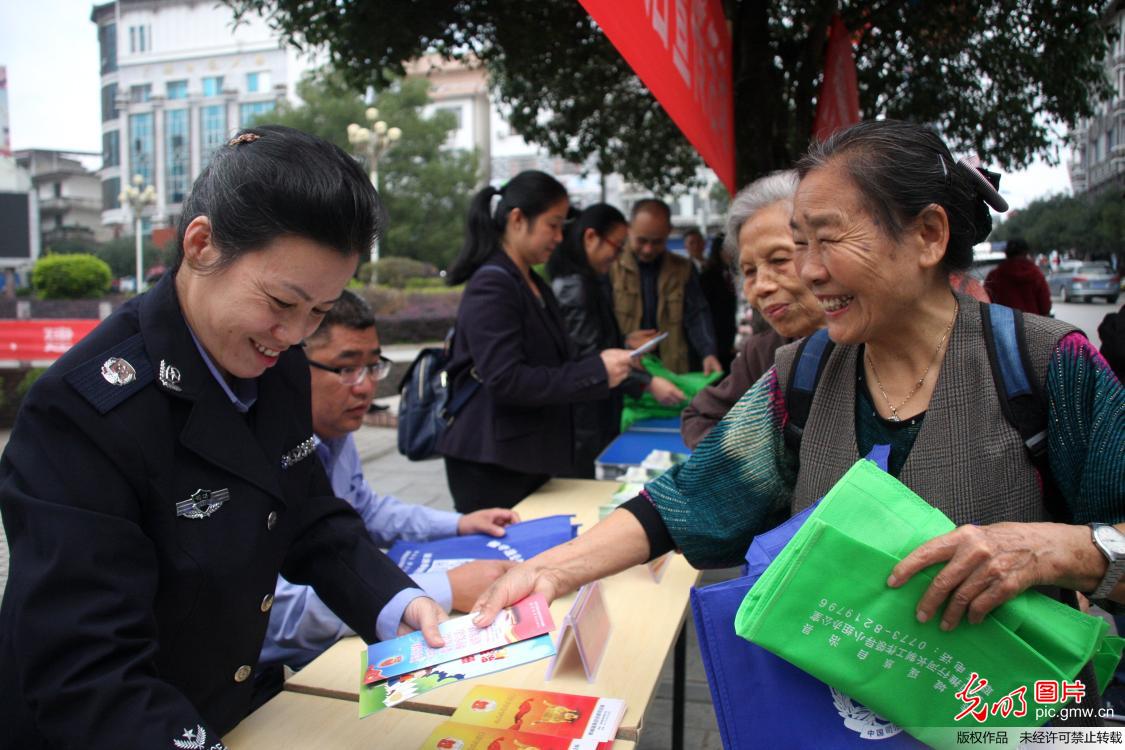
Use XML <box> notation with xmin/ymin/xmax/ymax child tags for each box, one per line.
<box><xmin>359</xmin><ymin>594</ymin><xmax>555</xmax><ymax>717</ymax></box>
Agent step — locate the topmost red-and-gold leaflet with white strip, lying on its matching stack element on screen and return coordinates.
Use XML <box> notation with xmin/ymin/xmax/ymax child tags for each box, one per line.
<box><xmin>450</xmin><ymin>685</ymin><xmax>626</xmax><ymax>742</ymax></box>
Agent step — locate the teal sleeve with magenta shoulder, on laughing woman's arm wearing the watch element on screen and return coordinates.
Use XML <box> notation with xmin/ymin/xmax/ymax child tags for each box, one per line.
<box><xmin>1047</xmin><ymin>333</ymin><xmax>1125</xmax><ymax>523</ymax></box>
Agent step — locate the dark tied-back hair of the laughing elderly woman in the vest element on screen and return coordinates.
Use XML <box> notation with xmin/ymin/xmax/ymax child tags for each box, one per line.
<box><xmin>797</xmin><ymin>120</ymin><xmax>999</xmax><ymax>271</ymax></box>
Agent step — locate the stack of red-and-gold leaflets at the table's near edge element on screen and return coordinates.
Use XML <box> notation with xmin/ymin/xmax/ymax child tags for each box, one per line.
<box><xmin>421</xmin><ymin>685</ymin><xmax>626</xmax><ymax>750</ymax></box>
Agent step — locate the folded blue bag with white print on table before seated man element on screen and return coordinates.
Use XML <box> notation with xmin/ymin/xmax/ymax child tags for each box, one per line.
<box><xmin>387</xmin><ymin>515</ymin><xmax>578</xmax><ymax>573</ymax></box>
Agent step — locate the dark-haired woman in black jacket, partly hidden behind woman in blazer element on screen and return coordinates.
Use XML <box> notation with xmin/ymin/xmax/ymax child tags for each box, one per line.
<box><xmin>547</xmin><ymin>204</ymin><xmax>684</xmax><ymax>479</ymax></box>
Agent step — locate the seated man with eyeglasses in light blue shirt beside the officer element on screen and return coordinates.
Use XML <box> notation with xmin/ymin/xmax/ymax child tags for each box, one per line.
<box><xmin>255</xmin><ymin>290</ymin><xmax>519</xmax><ymax>697</ymax></box>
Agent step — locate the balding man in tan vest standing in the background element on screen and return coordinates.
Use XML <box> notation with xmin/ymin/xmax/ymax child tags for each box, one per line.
<box><xmin>610</xmin><ymin>198</ymin><xmax>722</xmax><ymax>373</ymax></box>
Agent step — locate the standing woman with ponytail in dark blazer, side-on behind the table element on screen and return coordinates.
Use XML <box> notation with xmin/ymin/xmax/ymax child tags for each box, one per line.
<box><xmin>438</xmin><ymin>171</ymin><xmax>630</xmax><ymax>513</ymax></box>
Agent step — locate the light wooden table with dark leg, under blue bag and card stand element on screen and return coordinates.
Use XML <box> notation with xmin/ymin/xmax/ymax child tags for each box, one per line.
<box><xmin>285</xmin><ymin>479</ymin><xmax>700</xmax><ymax>744</ymax></box>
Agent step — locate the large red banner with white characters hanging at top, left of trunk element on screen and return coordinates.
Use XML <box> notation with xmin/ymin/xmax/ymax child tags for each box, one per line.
<box><xmin>578</xmin><ymin>0</ymin><xmax>736</xmax><ymax>193</ymax></box>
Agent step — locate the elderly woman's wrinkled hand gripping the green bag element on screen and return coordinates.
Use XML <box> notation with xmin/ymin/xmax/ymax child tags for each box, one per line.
<box><xmin>887</xmin><ymin>523</ymin><xmax>1089</xmax><ymax>631</ymax></box>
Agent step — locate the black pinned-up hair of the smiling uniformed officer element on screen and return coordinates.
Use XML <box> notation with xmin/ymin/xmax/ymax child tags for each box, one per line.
<box><xmin>173</xmin><ymin>125</ymin><xmax>384</xmax><ymax>271</ymax></box>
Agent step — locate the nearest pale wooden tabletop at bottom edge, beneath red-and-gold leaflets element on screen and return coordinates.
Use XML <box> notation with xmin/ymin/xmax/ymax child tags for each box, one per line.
<box><xmin>223</xmin><ymin>692</ymin><xmax>635</xmax><ymax>750</ymax></box>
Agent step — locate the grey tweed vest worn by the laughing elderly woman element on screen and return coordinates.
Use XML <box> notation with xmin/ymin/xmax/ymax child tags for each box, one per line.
<box><xmin>775</xmin><ymin>295</ymin><xmax>1076</xmax><ymax>525</ymax></box>
